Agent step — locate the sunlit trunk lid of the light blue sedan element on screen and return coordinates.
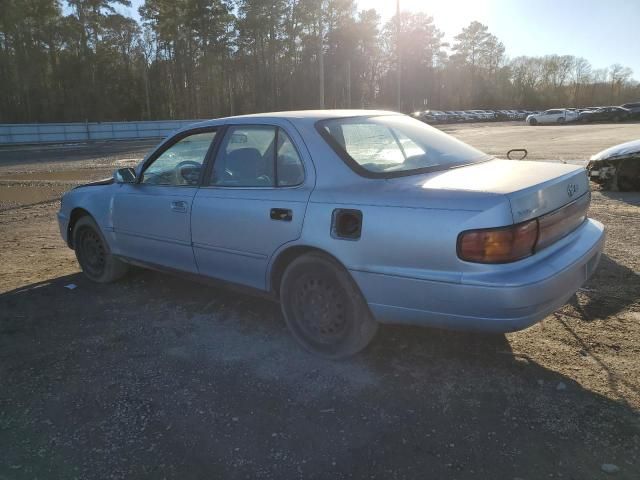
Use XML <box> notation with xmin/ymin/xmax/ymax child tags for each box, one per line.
<box><xmin>422</xmin><ymin>160</ymin><xmax>589</xmax><ymax>223</ymax></box>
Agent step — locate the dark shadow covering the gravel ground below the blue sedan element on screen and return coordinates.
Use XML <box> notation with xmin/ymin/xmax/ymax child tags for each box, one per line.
<box><xmin>0</xmin><ymin>270</ymin><xmax>640</xmax><ymax>479</ymax></box>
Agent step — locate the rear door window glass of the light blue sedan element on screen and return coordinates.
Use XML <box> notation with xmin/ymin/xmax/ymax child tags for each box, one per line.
<box><xmin>209</xmin><ymin>125</ymin><xmax>304</xmax><ymax>187</ymax></box>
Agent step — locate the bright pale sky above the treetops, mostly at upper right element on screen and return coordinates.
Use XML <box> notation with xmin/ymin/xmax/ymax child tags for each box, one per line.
<box><xmin>121</xmin><ymin>0</ymin><xmax>640</xmax><ymax>79</ymax></box>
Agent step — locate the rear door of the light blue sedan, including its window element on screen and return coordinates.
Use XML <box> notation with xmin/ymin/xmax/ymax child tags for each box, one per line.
<box><xmin>191</xmin><ymin>119</ymin><xmax>315</xmax><ymax>289</ymax></box>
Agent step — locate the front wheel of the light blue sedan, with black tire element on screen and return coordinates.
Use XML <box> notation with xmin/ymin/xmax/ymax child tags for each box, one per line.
<box><xmin>72</xmin><ymin>216</ymin><xmax>128</xmax><ymax>283</ymax></box>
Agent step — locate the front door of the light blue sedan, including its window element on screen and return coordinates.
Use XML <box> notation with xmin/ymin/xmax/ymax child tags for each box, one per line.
<box><xmin>112</xmin><ymin>128</ymin><xmax>216</xmax><ymax>273</ymax></box>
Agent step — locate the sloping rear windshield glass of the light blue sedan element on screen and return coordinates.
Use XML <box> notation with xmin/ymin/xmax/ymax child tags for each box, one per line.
<box><xmin>317</xmin><ymin>115</ymin><xmax>491</xmax><ymax>177</ymax></box>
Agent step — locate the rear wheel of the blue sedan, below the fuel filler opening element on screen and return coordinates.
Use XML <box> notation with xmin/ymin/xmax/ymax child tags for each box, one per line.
<box><xmin>280</xmin><ymin>253</ymin><xmax>378</xmax><ymax>359</ymax></box>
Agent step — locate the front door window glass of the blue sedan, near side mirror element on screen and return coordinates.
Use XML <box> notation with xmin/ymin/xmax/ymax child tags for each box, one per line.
<box><xmin>140</xmin><ymin>131</ymin><xmax>216</xmax><ymax>186</ymax></box>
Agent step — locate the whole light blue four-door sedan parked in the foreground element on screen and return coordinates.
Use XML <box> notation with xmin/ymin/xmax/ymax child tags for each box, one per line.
<box><xmin>58</xmin><ymin>110</ymin><xmax>605</xmax><ymax>358</ymax></box>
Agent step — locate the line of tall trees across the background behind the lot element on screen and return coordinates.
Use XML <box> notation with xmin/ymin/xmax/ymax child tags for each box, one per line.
<box><xmin>0</xmin><ymin>0</ymin><xmax>640</xmax><ymax>123</ymax></box>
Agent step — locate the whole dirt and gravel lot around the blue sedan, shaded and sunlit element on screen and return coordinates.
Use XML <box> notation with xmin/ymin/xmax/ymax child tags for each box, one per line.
<box><xmin>0</xmin><ymin>124</ymin><xmax>640</xmax><ymax>480</ymax></box>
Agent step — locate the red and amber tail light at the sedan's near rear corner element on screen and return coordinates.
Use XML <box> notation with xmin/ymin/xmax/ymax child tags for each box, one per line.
<box><xmin>458</xmin><ymin>220</ymin><xmax>538</xmax><ymax>263</ymax></box>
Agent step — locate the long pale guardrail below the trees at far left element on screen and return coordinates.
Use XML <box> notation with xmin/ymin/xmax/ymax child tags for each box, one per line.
<box><xmin>0</xmin><ymin>120</ymin><xmax>205</xmax><ymax>145</ymax></box>
